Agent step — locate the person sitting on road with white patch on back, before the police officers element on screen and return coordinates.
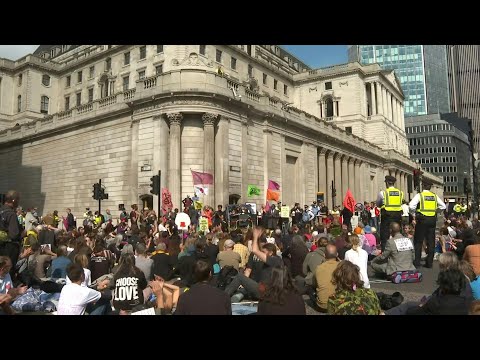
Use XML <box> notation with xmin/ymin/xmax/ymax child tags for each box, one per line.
<box><xmin>370</xmin><ymin>223</ymin><xmax>416</xmax><ymax>276</ymax></box>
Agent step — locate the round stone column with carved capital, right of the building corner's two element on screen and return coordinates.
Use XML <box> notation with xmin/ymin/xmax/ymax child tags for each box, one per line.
<box><xmin>202</xmin><ymin>113</ymin><xmax>218</xmax><ymax>209</ymax></box>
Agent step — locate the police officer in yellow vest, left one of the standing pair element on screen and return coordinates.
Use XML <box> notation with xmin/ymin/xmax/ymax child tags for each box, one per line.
<box><xmin>377</xmin><ymin>175</ymin><xmax>403</xmax><ymax>252</ymax></box>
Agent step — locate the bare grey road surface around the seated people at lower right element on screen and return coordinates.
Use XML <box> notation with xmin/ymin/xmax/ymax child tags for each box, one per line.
<box><xmin>303</xmin><ymin>261</ymin><xmax>439</xmax><ymax>315</ymax></box>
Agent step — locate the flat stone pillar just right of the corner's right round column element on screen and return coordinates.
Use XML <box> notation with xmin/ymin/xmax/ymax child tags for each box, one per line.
<box><xmin>214</xmin><ymin>116</ymin><xmax>230</xmax><ymax>209</ymax></box>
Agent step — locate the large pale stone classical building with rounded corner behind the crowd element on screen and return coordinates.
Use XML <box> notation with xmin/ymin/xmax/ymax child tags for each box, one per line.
<box><xmin>0</xmin><ymin>45</ymin><xmax>443</xmax><ymax>213</ymax></box>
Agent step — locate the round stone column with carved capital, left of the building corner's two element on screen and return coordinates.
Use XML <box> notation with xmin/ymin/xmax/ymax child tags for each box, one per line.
<box><xmin>167</xmin><ymin>113</ymin><xmax>183</xmax><ymax>210</ymax></box>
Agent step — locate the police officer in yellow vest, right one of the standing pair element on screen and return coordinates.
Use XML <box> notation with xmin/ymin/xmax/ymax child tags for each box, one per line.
<box><xmin>408</xmin><ymin>179</ymin><xmax>446</xmax><ymax>268</ymax></box>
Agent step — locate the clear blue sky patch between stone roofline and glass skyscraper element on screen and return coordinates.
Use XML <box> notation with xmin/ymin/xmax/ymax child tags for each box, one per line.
<box><xmin>282</xmin><ymin>45</ymin><xmax>348</xmax><ymax>68</ymax></box>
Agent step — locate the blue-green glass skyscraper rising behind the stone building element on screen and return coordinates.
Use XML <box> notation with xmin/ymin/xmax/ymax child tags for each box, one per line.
<box><xmin>348</xmin><ymin>45</ymin><xmax>450</xmax><ymax>116</ymax></box>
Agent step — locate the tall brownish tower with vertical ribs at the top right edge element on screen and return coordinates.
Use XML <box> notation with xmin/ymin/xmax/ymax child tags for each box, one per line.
<box><xmin>447</xmin><ymin>45</ymin><xmax>480</xmax><ymax>153</ymax></box>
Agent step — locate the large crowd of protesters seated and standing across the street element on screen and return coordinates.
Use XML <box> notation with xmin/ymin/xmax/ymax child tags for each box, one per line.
<box><xmin>0</xmin><ymin>191</ymin><xmax>480</xmax><ymax>315</ymax></box>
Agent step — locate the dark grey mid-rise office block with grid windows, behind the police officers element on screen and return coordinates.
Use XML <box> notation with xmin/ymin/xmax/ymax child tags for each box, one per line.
<box><xmin>405</xmin><ymin>113</ymin><xmax>472</xmax><ymax>199</ymax></box>
